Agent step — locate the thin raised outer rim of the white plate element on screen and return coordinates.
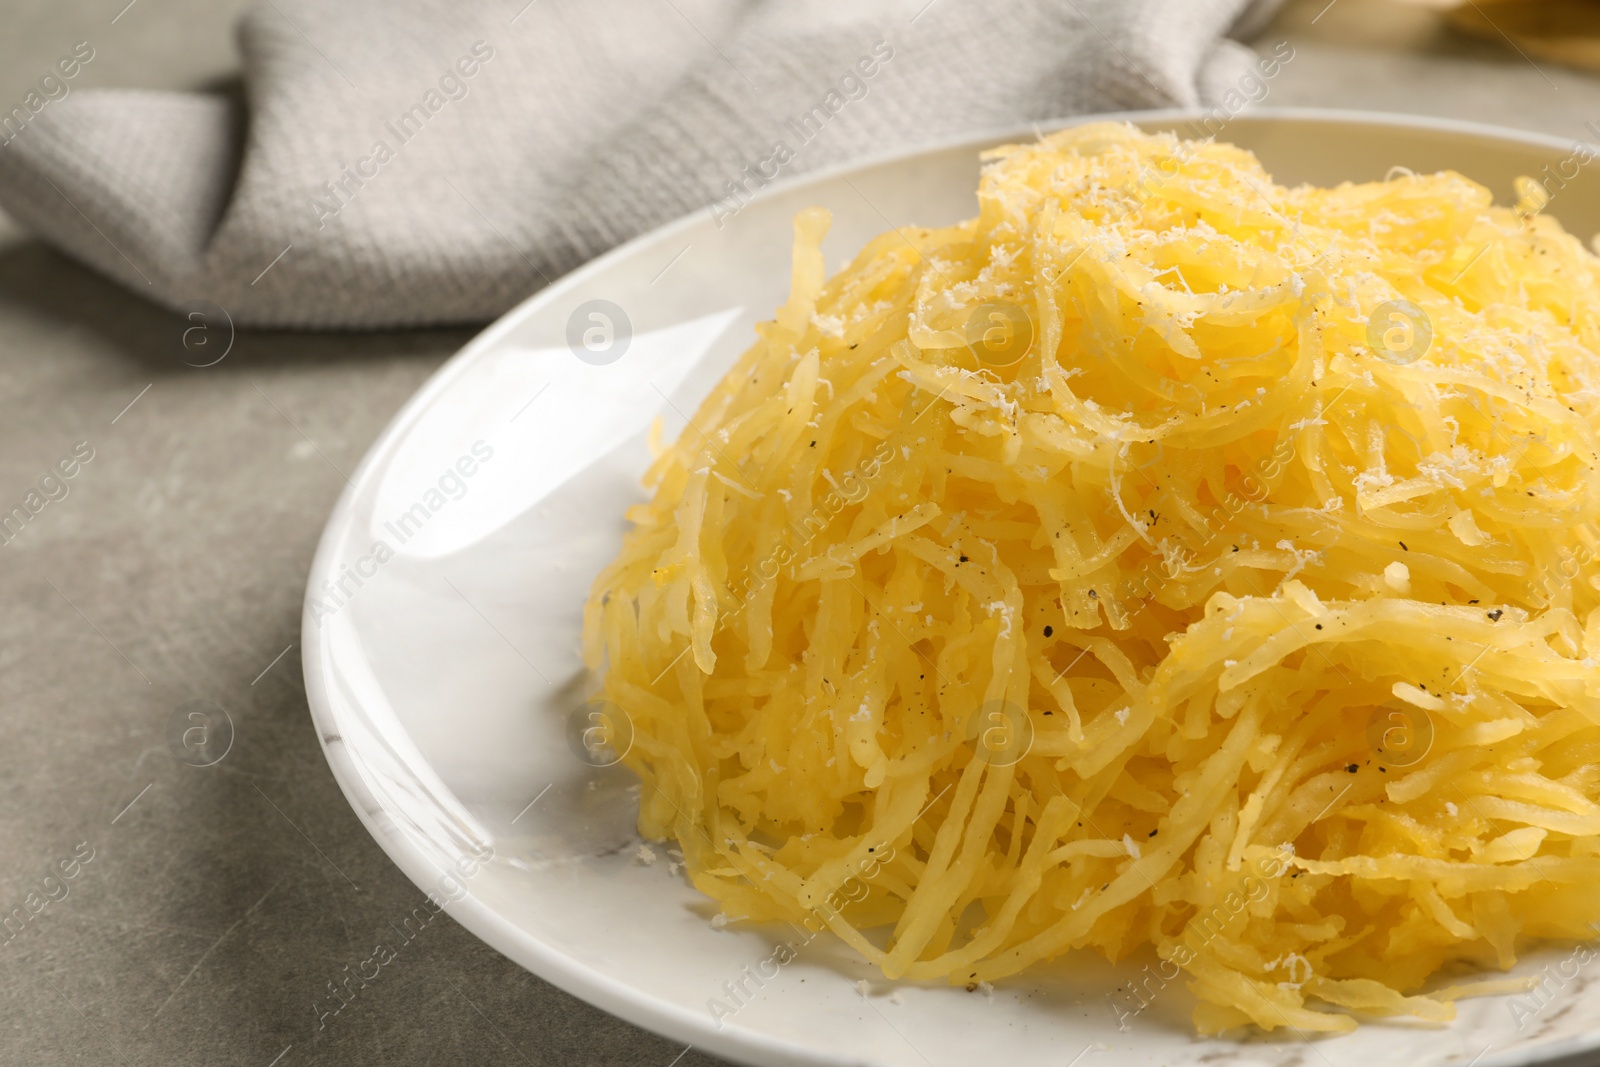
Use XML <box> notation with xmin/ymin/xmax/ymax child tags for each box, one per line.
<box><xmin>301</xmin><ymin>107</ymin><xmax>1600</xmax><ymax>1067</ymax></box>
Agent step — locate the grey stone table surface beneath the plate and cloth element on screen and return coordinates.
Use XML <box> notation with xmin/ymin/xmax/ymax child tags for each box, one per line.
<box><xmin>0</xmin><ymin>0</ymin><xmax>1600</xmax><ymax>1067</ymax></box>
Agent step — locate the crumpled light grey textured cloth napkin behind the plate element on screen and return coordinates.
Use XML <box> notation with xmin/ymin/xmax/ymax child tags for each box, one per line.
<box><xmin>0</xmin><ymin>0</ymin><xmax>1272</xmax><ymax>328</ymax></box>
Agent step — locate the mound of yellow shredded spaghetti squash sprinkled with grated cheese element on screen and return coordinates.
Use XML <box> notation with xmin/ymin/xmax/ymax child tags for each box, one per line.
<box><xmin>586</xmin><ymin>123</ymin><xmax>1600</xmax><ymax>1032</ymax></box>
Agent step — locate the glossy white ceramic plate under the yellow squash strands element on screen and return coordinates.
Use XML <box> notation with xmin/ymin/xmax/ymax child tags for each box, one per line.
<box><xmin>304</xmin><ymin>110</ymin><xmax>1600</xmax><ymax>1067</ymax></box>
